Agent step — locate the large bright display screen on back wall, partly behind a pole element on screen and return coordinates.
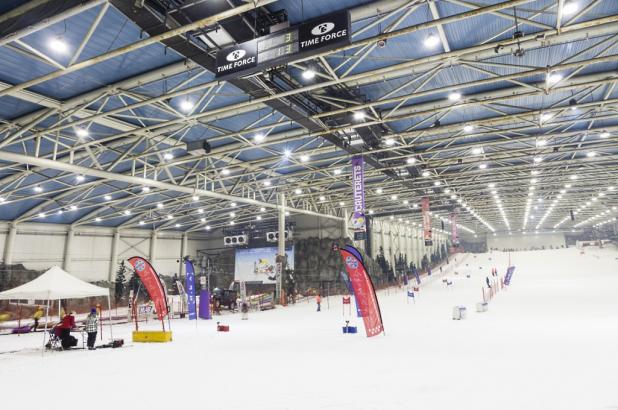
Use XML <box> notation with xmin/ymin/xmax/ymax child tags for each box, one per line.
<box><xmin>234</xmin><ymin>246</ymin><xmax>294</xmax><ymax>283</ymax></box>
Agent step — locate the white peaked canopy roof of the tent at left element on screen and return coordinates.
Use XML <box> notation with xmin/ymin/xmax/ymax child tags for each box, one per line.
<box><xmin>0</xmin><ymin>266</ymin><xmax>109</xmax><ymax>300</ymax></box>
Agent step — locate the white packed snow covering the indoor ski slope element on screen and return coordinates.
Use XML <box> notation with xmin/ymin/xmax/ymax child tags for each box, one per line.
<box><xmin>0</xmin><ymin>249</ymin><xmax>618</xmax><ymax>410</ymax></box>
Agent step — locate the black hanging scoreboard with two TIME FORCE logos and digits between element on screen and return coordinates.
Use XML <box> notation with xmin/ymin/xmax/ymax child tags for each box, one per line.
<box><xmin>215</xmin><ymin>11</ymin><xmax>351</xmax><ymax>79</ymax></box>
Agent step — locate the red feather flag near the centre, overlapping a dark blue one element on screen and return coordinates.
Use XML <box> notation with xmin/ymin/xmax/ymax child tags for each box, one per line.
<box><xmin>339</xmin><ymin>245</ymin><xmax>384</xmax><ymax>337</ymax></box>
